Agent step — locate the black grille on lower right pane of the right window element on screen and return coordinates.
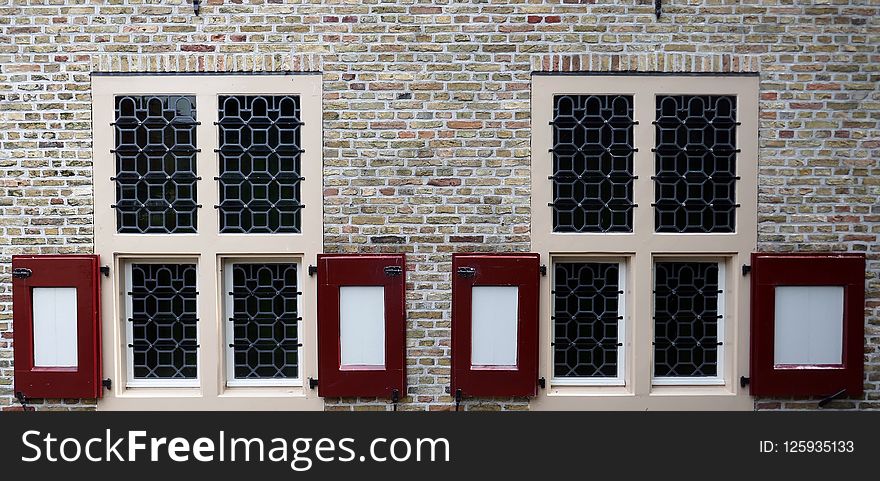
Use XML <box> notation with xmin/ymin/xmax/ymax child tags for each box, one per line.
<box><xmin>654</xmin><ymin>262</ymin><xmax>722</xmax><ymax>377</ymax></box>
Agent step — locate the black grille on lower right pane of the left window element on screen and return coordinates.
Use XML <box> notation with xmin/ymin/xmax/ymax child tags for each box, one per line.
<box><xmin>229</xmin><ymin>264</ymin><xmax>299</xmax><ymax>379</ymax></box>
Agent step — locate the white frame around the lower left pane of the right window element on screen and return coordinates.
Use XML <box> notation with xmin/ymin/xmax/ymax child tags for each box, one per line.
<box><xmin>550</xmin><ymin>256</ymin><xmax>630</xmax><ymax>386</ymax></box>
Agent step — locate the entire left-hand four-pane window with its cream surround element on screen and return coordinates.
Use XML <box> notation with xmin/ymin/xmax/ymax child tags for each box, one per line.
<box><xmin>92</xmin><ymin>75</ymin><xmax>323</xmax><ymax>409</ymax></box>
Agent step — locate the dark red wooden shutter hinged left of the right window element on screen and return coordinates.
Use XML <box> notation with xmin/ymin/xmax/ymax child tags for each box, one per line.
<box><xmin>452</xmin><ymin>254</ymin><xmax>540</xmax><ymax>396</ymax></box>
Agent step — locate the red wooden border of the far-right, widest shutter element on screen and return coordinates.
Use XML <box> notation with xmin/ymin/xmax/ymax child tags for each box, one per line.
<box><xmin>749</xmin><ymin>253</ymin><xmax>865</xmax><ymax>397</ymax></box>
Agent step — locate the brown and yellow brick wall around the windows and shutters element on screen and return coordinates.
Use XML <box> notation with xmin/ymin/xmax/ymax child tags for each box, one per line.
<box><xmin>0</xmin><ymin>0</ymin><xmax>880</xmax><ymax>410</ymax></box>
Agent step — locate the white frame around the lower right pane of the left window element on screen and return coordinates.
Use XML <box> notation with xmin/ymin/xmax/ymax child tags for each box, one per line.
<box><xmin>220</xmin><ymin>257</ymin><xmax>305</xmax><ymax>387</ymax></box>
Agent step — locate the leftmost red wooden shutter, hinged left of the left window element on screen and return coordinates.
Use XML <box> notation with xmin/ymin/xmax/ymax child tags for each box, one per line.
<box><xmin>12</xmin><ymin>255</ymin><xmax>102</xmax><ymax>399</ymax></box>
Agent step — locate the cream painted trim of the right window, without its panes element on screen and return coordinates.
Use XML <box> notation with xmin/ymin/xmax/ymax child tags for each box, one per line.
<box><xmin>530</xmin><ymin>75</ymin><xmax>758</xmax><ymax>410</ymax></box>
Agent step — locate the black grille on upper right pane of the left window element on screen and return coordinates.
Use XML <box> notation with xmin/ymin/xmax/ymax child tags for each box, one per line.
<box><xmin>218</xmin><ymin>95</ymin><xmax>304</xmax><ymax>233</ymax></box>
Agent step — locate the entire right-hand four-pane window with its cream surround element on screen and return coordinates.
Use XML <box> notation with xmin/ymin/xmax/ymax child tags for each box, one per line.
<box><xmin>531</xmin><ymin>75</ymin><xmax>758</xmax><ymax>409</ymax></box>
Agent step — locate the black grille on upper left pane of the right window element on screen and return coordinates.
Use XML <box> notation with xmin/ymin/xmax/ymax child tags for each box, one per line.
<box><xmin>550</xmin><ymin>95</ymin><xmax>636</xmax><ymax>232</ymax></box>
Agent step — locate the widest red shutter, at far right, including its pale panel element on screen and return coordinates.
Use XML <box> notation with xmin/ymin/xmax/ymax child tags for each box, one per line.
<box><xmin>749</xmin><ymin>253</ymin><xmax>865</xmax><ymax>397</ymax></box>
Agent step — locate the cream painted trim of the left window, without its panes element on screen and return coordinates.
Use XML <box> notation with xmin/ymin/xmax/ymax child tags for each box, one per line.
<box><xmin>92</xmin><ymin>74</ymin><xmax>324</xmax><ymax>410</ymax></box>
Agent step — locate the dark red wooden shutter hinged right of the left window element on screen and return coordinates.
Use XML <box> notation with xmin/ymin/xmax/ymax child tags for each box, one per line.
<box><xmin>318</xmin><ymin>254</ymin><xmax>406</xmax><ymax>399</ymax></box>
